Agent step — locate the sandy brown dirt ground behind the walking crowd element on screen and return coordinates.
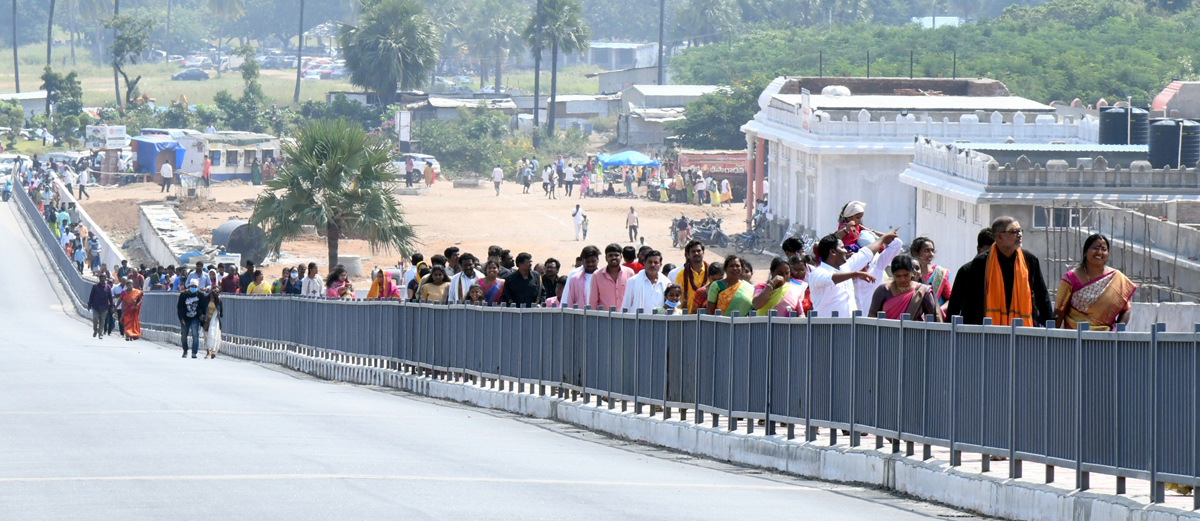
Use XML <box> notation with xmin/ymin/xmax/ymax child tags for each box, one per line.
<box><xmin>83</xmin><ymin>180</ymin><xmax>770</xmax><ymax>281</ymax></box>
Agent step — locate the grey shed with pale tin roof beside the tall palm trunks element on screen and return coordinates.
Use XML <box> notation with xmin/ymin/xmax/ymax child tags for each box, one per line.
<box><xmin>617</xmin><ymin>85</ymin><xmax>721</xmax><ymax>149</ymax></box>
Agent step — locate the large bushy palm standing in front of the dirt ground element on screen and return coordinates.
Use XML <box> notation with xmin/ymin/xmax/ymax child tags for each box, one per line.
<box><xmin>250</xmin><ymin>120</ymin><xmax>415</xmax><ymax>267</ymax></box>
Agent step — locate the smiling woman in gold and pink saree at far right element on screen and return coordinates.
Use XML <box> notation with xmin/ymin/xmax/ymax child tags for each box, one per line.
<box><xmin>1055</xmin><ymin>233</ymin><xmax>1138</xmax><ymax>331</ymax></box>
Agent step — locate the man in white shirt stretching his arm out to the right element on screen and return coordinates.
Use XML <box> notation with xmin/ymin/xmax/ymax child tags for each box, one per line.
<box><xmin>809</xmin><ymin>229</ymin><xmax>896</xmax><ymax>317</ymax></box>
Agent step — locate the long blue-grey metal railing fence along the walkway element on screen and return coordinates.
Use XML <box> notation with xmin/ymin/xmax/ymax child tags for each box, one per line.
<box><xmin>14</xmin><ymin>172</ymin><xmax>1200</xmax><ymax>508</ymax></box>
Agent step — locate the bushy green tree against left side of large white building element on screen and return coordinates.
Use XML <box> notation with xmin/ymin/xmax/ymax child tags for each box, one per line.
<box><xmin>666</xmin><ymin>77</ymin><xmax>769</xmax><ymax>150</ymax></box>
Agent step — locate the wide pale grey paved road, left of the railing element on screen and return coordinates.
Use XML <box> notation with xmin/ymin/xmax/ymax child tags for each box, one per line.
<box><xmin>0</xmin><ymin>201</ymin><xmax>974</xmax><ymax>521</ymax></box>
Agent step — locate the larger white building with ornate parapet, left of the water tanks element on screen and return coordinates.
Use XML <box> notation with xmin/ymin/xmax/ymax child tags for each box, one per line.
<box><xmin>742</xmin><ymin>78</ymin><xmax>1098</xmax><ymax>241</ymax></box>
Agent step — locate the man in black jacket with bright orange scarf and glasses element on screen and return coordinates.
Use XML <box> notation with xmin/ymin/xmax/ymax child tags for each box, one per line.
<box><xmin>962</xmin><ymin>216</ymin><xmax>1054</xmax><ymax>327</ymax></box>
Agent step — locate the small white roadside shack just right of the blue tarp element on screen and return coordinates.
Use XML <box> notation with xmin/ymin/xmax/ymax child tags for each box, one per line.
<box><xmin>179</xmin><ymin>132</ymin><xmax>280</xmax><ymax>181</ymax></box>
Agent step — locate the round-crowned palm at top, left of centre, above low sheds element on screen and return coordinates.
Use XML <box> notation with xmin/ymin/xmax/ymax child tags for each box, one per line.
<box><xmin>338</xmin><ymin>0</ymin><xmax>439</xmax><ymax>106</ymax></box>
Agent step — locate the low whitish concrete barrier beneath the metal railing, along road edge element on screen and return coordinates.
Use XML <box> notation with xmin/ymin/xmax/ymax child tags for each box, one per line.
<box><xmin>143</xmin><ymin>330</ymin><xmax>1200</xmax><ymax>521</ymax></box>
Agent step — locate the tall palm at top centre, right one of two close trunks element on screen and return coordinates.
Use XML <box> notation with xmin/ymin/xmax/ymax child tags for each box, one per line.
<box><xmin>524</xmin><ymin>0</ymin><xmax>592</xmax><ymax>136</ymax></box>
